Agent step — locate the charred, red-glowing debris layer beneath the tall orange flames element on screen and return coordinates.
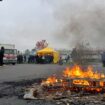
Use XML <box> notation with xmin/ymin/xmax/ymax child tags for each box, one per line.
<box><xmin>42</xmin><ymin>78</ymin><xmax>105</xmax><ymax>93</ymax></box>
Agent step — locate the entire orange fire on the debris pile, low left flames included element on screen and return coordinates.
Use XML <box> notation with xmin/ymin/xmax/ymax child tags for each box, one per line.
<box><xmin>42</xmin><ymin>65</ymin><xmax>105</xmax><ymax>92</ymax></box>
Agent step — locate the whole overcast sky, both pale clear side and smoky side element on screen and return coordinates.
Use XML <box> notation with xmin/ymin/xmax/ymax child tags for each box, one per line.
<box><xmin>0</xmin><ymin>0</ymin><xmax>105</xmax><ymax>50</ymax></box>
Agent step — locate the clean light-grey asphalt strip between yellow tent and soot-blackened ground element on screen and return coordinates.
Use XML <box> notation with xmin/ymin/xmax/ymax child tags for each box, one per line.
<box><xmin>0</xmin><ymin>64</ymin><xmax>65</xmax><ymax>82</ymax></box>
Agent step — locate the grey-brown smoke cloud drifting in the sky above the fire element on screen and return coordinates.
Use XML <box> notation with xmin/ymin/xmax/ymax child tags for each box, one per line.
<box><xmin>49</xmin><ymin>0</ymin><xmax>105</xmax><ymax>48</ymax></box>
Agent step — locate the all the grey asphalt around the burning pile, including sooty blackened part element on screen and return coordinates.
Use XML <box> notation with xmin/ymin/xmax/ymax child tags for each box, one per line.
<box><xmin>0</xmin><ymin>64</ymin><xmax>105</xmax><ymax>105</ymax></box>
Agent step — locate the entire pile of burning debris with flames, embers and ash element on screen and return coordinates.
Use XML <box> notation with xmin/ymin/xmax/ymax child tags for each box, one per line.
<box><xmin>24</xmin><ymin>65</ymin><xmax>105</xmax><ymax>105</ymax></box>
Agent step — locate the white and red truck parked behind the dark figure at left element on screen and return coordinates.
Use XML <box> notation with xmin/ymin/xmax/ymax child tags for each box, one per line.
<box><xmin>0</xmin><ymin>44</ymin><xmax>17</xmax><ymax>65</ymax></box>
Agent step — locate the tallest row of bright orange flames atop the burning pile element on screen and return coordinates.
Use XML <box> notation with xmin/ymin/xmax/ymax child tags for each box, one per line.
<box><xmin>63</xmin><ymin>65</ymin><xmax>105</xmax><ymax>79</ymax></box>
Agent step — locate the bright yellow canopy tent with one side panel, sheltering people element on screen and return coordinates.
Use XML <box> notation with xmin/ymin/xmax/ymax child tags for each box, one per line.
<box><xmin>37</xmin><ymin>47</ymin><xmax>59</xmax><ymax>63</ymax></box>
